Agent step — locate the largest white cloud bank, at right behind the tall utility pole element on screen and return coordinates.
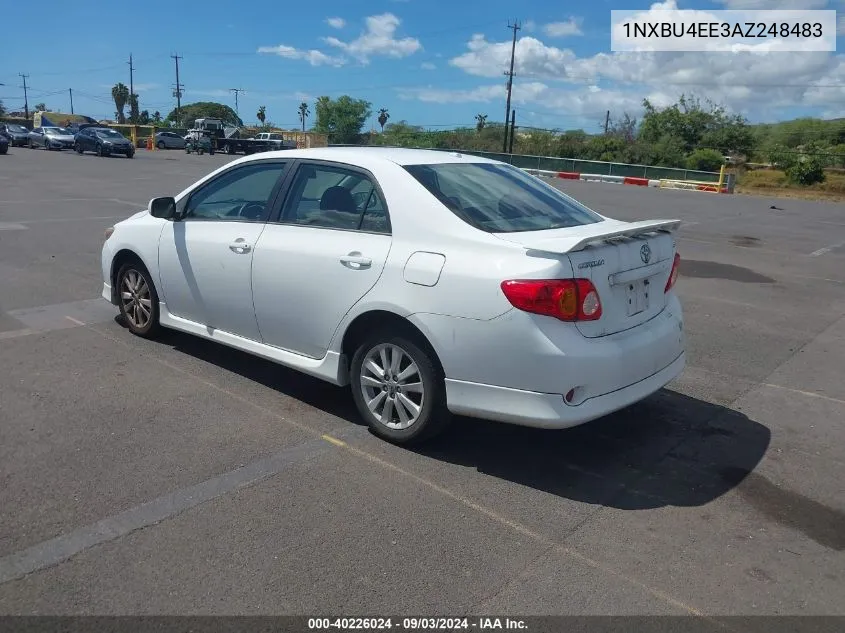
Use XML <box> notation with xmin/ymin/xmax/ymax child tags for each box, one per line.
<box><xmin>436</xmin><ymin>20</ymin><xmax>845</xmax><ymax>121</ymax></box>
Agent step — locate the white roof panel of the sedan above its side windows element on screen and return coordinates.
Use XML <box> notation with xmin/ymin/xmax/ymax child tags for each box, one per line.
<box><xmin>234</xmin><ymin>147</ymin><xmax>499</xmax><ymax>168</ymax></box>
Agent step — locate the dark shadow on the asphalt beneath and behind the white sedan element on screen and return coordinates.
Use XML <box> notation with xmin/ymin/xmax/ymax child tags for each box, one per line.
<box><xmin>130</xmin><ymin>318</ymin><xmax>771</xmax><ymax>510</ymax></box>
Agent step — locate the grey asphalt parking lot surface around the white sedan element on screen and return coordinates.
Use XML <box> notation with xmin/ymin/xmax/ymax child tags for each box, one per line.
<box><xmin>0</xmin><ymin>148</ymin><xmax>845</xmax><ymax>615</ymax></box>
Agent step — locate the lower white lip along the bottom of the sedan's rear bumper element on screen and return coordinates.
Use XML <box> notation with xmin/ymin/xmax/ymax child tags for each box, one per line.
<box><xmin>446</xmin><ymin>353</ymin><xmax>686</xmax><ymax>429</ymax></box>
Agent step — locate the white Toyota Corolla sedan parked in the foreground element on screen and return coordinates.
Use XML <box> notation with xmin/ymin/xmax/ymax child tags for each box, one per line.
<box><xmin>102</xmin><ymin>148</ymin><xmax>685</xmax><ymax>443</ymax></box>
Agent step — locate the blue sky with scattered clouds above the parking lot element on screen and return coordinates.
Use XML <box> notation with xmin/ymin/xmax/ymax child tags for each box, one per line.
<box><xmin>0</xmin><ymin>0</ymin><xmax>845</xmax><ymax>131</ymax></box>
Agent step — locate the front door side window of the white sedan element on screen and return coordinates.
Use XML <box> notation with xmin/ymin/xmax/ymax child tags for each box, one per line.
<box><xmin>184</xmin><ymin>162</ymin><xmax>285</xmax><ymax>222</ymax></box>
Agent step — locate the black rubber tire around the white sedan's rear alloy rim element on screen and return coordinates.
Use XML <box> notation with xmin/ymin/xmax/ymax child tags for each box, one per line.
<box><xmin>350</xmin><ymin>328</ymin><xmax>451</xmax><ymax>445</ymax></box>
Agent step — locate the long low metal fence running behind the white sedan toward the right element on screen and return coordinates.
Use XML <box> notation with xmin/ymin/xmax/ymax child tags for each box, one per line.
<box><xmin>330</xmin><ymin>146</ymin><xmax>719</xmax><ymax>182</ymax></box>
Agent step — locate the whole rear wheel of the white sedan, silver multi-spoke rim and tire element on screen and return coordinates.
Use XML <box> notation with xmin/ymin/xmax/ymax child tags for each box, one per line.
<box><xmin>350</xmin><ymin>331</ymin><xmax>451</xmax><ymax>444</ymax></box>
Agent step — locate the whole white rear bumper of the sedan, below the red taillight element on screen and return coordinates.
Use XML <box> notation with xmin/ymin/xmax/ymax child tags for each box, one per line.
<box><xmin>409</xmin><ymin>294</ymin><xmax>686</xmax><ymax>428</ymax></box>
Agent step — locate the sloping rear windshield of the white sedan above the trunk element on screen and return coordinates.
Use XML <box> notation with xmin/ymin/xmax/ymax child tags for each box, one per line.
<box><xmin>405</xmin><ymin>163</ymin><xmax>602</xmax><ymax>233</ymax></box>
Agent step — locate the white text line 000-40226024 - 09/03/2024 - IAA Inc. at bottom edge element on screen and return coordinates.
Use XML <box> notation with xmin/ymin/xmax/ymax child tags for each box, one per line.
<box><xmin>308</xmin><ymin>617</ymin><xmax>528</xmax><ymax>631</ymax></box>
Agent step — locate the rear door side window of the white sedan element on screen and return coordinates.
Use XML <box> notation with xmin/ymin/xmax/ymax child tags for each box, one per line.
<box><xmin>282</xmin><ymin>165</ymin><xmax>390</xmax><ymax>233</ymax></box>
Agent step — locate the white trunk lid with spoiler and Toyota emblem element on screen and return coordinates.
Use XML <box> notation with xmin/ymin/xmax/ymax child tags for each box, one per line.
<box><xmin>496</xmin><ymin>220</ymin><xmax>680</xmax><ymax>338</ymax></box>
